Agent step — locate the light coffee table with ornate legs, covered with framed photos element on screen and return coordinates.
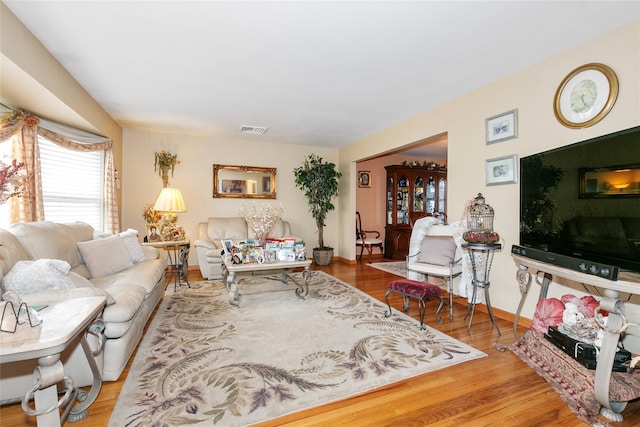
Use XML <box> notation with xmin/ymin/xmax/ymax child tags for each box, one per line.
<box><xmin>222</xmin><ymin>256</ymin><xmax>311</xmax><ymax>305</ymax></box>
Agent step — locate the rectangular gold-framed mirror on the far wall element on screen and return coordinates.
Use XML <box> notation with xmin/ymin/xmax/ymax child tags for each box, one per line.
<box><xmin>213</xmin><ymin>164</ymin><xmax>276</xmax><ymax>199</ymax></box>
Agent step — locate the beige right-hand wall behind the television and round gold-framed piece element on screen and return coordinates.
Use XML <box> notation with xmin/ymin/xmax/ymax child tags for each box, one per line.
<box><xmin>340</xmin><ymin>21</ymin><xmax>640</xmax><ymax>342</ymax></box>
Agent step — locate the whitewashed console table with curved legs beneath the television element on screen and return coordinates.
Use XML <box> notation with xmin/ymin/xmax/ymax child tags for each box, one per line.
<box><xmin>512</xmin><ymin>254</ymin><xmax>640</xmax><ymax>421</ymax></box>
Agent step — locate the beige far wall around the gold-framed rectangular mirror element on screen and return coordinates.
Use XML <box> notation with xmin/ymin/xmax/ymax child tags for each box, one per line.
<box><xmin>122</xmin><ymin>129</ymin><xmax>338</xmax><ymax>254</ymax></box>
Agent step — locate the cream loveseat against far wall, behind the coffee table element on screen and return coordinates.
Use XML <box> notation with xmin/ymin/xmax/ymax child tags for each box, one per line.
<box><xmin>194</xmin><ymin>217</ymin><xmax>299</xmax><ymax>280</ymax></box>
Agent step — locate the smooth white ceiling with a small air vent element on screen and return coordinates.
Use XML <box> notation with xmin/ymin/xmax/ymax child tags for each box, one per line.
<box><xmin>3</xmin><ymin>0</ymin><xmax>640</xmax><ymax>159</ymax></box>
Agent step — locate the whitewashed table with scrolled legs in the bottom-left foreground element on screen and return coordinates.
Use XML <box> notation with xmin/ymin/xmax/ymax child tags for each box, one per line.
<box><xmin>0</xmin><ymin>297</ymin><xmax>106</xmax><ymax>427</ymax></box>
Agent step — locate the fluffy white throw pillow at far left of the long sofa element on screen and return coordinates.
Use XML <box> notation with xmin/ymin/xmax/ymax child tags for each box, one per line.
<box><xmin>3</xmin><ymin>258</ymin><xmax>74</xmax><ymax>295</ymax></box>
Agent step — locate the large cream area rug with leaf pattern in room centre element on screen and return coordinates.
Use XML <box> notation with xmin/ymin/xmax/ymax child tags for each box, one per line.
<box><xmin>109</xmin><ymin>271</ymin><xmax>486</xmax><ymax>427</ymax></box>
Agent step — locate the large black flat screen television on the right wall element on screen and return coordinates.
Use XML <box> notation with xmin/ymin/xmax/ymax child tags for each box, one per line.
<box><xmin>519</xmin><ymin>126</ymin><xmax>640</xmax><ymax>272</ymax></box>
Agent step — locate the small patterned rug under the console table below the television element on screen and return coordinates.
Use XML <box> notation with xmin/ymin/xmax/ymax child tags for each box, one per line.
<box><xmin>509</xmin><ymin>331</ymin><xmax>640</xmax><ymax>427</ymax></box>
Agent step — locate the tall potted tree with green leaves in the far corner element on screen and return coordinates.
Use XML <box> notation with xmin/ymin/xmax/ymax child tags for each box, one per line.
<box><xmin>293</xmin><ymin>154</ymin><xmax>342</xmax><ymax>265</ymax></box>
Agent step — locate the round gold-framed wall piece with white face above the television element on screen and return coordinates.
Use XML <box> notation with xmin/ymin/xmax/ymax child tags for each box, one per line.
<box><xmin>553</xmin><ymin>63</ymin><xmax>618</xmax><ymax>129</ymax></box>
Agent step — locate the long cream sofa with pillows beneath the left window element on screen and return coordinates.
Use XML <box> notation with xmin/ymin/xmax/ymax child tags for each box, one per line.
<box><xmin>0</xmin><ymin>221</ymin><xmax>166</xmax><ymax>403</ymax></box>
